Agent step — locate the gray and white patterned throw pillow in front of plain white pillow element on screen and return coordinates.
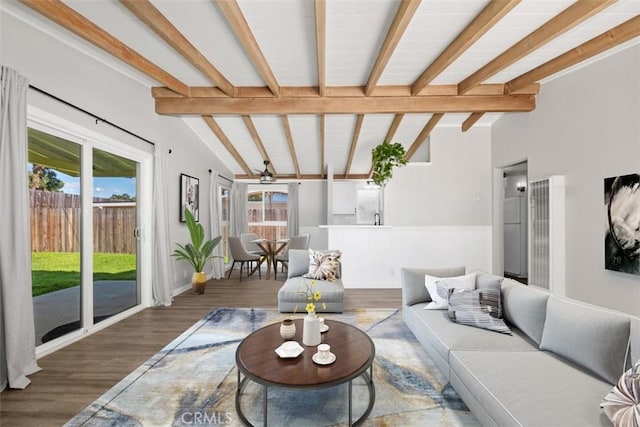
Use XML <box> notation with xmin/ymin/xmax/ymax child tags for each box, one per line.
<box><xmin>449</xmin><ymin>289</ymin><xmax>511</xmax><ymax>335</ymax></box>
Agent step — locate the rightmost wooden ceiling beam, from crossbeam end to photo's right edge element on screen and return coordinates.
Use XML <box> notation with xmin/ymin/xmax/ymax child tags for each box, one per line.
<box><xmin>505</xmin><ymin>15</ymin><xmax>640</xmax><ymax>93</ymax></box>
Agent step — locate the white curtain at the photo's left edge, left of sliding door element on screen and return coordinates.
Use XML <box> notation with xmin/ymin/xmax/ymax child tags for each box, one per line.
<box><xmin>0</xmin><ymin>67</ymin><xmax>40</xmax><ymax>391</ymax></box>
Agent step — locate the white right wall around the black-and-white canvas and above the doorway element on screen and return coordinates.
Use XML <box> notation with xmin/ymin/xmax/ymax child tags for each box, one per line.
<box><xmin>492</xmin><ymin>45</ymin><xmax>640</xmax><ymax>315</ymax></box>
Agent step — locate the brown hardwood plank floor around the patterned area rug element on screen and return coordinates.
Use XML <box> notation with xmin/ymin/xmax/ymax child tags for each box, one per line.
<box><xmin>0</xmin><ymin>271</ymin><xmax>401</xmax><ymax>427</ymax></box>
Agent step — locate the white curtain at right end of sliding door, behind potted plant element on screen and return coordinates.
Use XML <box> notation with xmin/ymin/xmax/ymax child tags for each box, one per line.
<box><xmin>152</xmin><ymin>146</ymin><xmax>174</xmax><ymax>306</ymax></box>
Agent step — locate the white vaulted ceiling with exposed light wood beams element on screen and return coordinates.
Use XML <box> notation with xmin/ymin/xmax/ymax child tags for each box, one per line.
<box><xmin>2</xmin><ymin>0</ymin><xmax>640</xmax><ymax>179</ymax></box>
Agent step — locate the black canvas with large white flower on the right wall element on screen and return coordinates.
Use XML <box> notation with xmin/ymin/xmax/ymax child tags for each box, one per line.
<box><xmin>604</xmin><ymin>174</ymin><xmax>640</xmax><ymax>275</ymax></box>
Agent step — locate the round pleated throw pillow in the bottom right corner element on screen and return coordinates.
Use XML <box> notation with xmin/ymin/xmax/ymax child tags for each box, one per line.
<box><xmin>600</xmin><ymin>360</ymin><xmax>640</xmax><ymax>427</ymax></box>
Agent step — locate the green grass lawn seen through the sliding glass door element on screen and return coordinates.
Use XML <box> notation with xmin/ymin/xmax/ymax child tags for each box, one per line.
<box><xmin>31</xmin><ymin>252</ymin><xmax>136</xmax><ymax>297</ymax></box>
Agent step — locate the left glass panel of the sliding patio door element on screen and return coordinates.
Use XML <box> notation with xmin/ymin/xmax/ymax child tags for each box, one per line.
<box><xmin>27</xmin><ymin>128</ymin><xmax>81</xmax><ymax>345</ymax></box>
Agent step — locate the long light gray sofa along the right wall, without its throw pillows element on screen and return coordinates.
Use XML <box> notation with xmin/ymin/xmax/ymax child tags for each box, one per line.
<box><xmin>402</xmin><ymin>267</ymin><xmax>640</xmax><ymax>427</ymax></box>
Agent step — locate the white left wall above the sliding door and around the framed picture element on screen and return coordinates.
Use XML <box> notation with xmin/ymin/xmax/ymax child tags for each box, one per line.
<box><xmin>0</xmin><ymin>10</ymin><xmax>231</xmax><ymax>289</ymax></box>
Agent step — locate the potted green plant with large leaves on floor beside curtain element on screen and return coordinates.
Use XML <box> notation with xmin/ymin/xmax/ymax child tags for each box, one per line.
<box><xmin>171</xmin><ymin>208</ymin><xmax>222</xmax><ymax>294</ymax></box>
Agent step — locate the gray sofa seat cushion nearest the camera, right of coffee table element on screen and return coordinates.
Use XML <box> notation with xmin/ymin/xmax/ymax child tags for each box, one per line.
<box><xmin>450</xmin><ymin>352</ymin><xmax>611</xmax><ymax>427</ymax></box>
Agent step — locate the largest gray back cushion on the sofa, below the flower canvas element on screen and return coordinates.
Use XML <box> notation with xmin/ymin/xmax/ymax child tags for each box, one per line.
<box><xmin>540</xmin><ymin>297</ymin><xmax>631</xmax><ymax>384</ymax></box>
